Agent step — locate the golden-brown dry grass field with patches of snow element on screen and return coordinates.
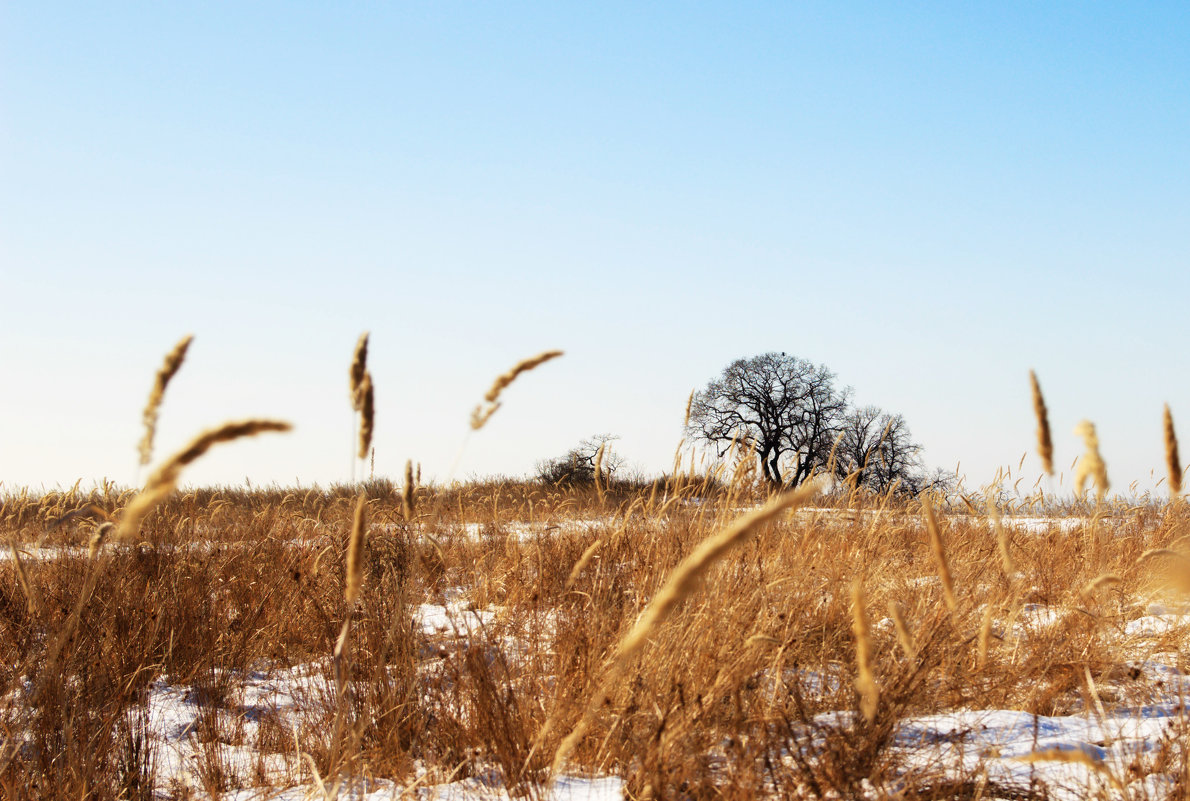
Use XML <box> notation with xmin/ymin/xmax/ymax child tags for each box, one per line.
<box><xmin>0</xmin><ymin>475</ymin><xmax>1190</xmax><ymax>801</ymax></box>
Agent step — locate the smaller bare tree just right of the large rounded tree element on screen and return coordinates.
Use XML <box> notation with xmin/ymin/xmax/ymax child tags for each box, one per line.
<box><xmin>834</xmin><ymin>406</ymin><xmax>927</xmax><ymax>495</ymax></box>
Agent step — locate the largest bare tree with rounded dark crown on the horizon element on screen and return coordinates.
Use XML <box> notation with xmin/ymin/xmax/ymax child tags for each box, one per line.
<box><xmin>688</xmin><ymin>352</ymin><xmax>851</xmax><ymax>487</ymax></box>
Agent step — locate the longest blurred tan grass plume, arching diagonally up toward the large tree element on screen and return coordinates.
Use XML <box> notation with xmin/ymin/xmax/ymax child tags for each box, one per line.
<box><xmin>552</xmin><ymin>482</ymin><xmax>819</xmax><ymax>775</ymax></box>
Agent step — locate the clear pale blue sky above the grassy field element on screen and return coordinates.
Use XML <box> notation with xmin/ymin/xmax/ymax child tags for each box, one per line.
<box><xmin>0</xmin><ymin>1</ymin><xmax>1190</xmax><ymax>489</ymax></box>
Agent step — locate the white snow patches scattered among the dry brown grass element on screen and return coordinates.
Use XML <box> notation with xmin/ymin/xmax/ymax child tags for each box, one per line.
<box><xmin>9</xmin><ymin>508</ymin><xmax>1190</xmax><ymax>801</ymax></box>
